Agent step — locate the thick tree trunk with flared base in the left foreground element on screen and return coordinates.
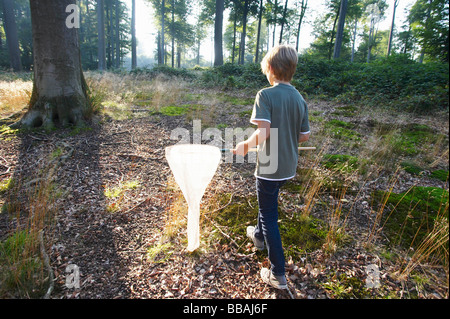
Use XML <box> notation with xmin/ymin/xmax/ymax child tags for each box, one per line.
<box><xmin>18</xmin><ymin>0</ymin><xmax>90</xmax><ymax>128</ymax></box>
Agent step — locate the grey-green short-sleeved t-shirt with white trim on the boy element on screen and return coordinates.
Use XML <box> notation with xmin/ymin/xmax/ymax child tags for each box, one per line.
<box><xmin>250</xmin><ymin>83</ymin><xmax>310</xmax><ymax>180</ymax></box>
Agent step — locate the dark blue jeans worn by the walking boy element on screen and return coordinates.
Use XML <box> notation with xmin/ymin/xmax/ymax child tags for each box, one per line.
<box><xmin>255</xmin><ymin>178</ymin><xmax>286</xmax><ymax>276</ymax></box>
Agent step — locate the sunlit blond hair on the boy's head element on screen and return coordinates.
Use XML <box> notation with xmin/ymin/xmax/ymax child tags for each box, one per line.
<box><xmin>261</xmin><ymin>45</ymin><xmax>298</xmax><ymax>82</ymax></box>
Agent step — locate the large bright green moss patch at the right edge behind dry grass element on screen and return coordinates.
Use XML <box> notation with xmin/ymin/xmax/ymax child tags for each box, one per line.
<box><xmin>372</xmin><ymin>186</ymin><xmax>449</xmax><ymax>248</ymax></box>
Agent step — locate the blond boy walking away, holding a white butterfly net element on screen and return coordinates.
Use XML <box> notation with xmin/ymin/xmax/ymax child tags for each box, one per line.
<box><xmin>233</xmin><ymin>45</ymin><xmax>310</xmax><ymax>289</ymax></box>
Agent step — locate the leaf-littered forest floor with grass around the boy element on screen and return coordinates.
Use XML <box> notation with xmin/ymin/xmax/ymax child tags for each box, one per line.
<box><xmin>0</xmin><ymin>73</ymin><xmax>448</xmax><ymax>299</ymax></box>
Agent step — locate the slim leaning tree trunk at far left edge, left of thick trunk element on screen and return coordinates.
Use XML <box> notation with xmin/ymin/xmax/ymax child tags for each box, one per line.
<box><xmin>2</xmin><ymin>0</ymin><xmax>22</xmax><ymax>72</ymax></box>
